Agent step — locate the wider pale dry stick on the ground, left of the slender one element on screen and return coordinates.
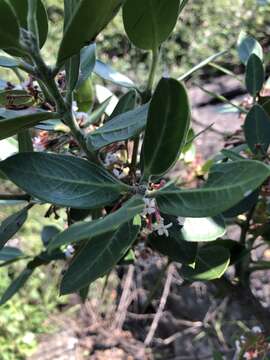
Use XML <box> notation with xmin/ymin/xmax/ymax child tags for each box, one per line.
<box><xmin>112</xmin><ymin>265</ymin><xmax>135</xmax><ymax>329</ymax></box>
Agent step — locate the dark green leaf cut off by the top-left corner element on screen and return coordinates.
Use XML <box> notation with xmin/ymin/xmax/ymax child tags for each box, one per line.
<box><xmin>0</xmin><ymin>0</ymin><xmax>20</xmax><ymax>49</ymax></box>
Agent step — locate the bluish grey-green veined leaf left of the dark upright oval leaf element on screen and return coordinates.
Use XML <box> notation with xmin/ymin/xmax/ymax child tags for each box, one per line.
<box><xmin>88</xmin><ymin>104</ymin><xmax>149</xmax><ymax>150</ymax></box>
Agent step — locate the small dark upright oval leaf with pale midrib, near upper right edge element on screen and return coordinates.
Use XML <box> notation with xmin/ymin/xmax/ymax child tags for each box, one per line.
<box><xmin>246</xmin><ymin>54</ymin><xmax>265</xmax><ymax>97</ymax></box>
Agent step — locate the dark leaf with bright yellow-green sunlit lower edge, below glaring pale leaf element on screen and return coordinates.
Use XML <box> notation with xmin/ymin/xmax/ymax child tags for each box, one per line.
<box><xmin>180</xmin><ymin>246</ymin><xmax>230</xmax><ymax>281</ymax></box>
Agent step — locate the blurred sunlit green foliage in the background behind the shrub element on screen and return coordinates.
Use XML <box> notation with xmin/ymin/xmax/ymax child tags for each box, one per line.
<box><xmin>0</xmin><ymin>0</ymin><xmax>270</xmax><ymax>360</ymax></box>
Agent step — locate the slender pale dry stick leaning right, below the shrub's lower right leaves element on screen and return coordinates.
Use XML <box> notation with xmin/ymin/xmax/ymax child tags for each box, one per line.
<box><xmin>144</xmin><ymin>265</ymin><xmax>173</xmax><ymax>346</ymax></box>
